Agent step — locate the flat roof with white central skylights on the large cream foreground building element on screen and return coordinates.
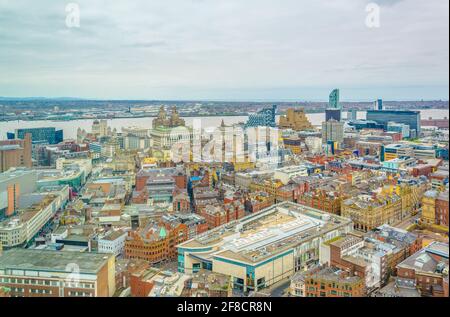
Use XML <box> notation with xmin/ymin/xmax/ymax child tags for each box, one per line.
<box><xmin>178</xmin><ymin>202</ymin><xmax>351</xmax><ymax>263</ymax></box>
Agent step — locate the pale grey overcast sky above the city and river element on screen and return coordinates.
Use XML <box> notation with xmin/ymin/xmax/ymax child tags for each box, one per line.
<box><xmin>0</xmin><ymin>0</ymin><xmax>449</xmax><ymax>101</ymax></box>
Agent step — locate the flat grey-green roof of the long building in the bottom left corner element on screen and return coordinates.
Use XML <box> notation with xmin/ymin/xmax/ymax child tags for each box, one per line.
<box><xmin>0</xmin><ymin>249</ymin><xmax>113</xmax><ymax>274</ymax></box>
